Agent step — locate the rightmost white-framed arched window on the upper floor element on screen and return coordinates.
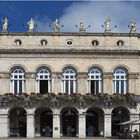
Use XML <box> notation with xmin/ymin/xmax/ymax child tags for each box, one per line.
<box><xmin>113</xmin><ymin>68</ymin><xmax>128</xmax><ymax>93</ymax></box>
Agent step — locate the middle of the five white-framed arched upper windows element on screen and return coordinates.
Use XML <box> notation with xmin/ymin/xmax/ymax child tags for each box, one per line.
<box><xmin>62</xmin><ymin>67</ymin><xmax>76</xmax><ymax>95</ymax></box>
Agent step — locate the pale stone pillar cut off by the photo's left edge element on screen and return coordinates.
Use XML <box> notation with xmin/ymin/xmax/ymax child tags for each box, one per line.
<box><xmin>0</xmin><ymin>114</ymin><xmax>9</xmax><ymax>138</ymax></box>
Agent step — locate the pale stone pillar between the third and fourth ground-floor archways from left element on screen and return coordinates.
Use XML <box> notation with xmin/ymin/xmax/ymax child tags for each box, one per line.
<box><xmin>79</xmin><ymin>114</ymin><xmax>86</xmax><ymax>138</ymax></box>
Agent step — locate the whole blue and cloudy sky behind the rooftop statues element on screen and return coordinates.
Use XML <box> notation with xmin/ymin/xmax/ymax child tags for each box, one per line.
<box><xmin>0</xmin><ymin>1</ymin><xmax>140</xmax><ymax>32</ymax></box>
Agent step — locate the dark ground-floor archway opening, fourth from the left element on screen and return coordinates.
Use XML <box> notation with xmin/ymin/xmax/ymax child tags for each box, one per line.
<box><xmin>86</xmin><ymin>108</ymin><xmax>104</xmax><ymax>137</ymax></box>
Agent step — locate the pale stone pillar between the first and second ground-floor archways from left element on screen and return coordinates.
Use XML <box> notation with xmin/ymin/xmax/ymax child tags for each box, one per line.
<box><xmin>27</xmin><ymin>114</ymin><xmax>35</xmax><ymax>138</ymax></box>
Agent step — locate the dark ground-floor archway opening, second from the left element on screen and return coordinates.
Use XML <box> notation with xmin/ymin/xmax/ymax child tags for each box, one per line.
<box><xmin>35</xmin><ymin>108</ymin><xmax>53</xmax><ymax>137</ymax></box>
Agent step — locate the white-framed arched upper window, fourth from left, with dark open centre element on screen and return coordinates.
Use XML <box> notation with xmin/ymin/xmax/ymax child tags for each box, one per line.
<box><xmin>88</xmin><ymin>68</ymin><xmax>102</xmax><ymax>93</ymax></box>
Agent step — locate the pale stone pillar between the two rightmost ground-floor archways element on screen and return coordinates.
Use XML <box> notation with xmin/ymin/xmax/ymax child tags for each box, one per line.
<box><xmin>104</xmin><ymin>114</ymin><xmax>111</xmax><ymax>137</ymax></box>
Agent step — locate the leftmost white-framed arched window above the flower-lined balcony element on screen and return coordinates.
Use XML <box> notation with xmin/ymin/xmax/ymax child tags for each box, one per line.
<box><xmin>10</xmin><ymin>67</ymin><xmax>25</xmax><ymax>94</ymax></box>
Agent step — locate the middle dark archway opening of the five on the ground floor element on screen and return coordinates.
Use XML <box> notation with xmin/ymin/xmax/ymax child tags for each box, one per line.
<box><xmin>61</xmin><ymin>108</ymin><xmax>78</xmax><ymax>137</ymax></box>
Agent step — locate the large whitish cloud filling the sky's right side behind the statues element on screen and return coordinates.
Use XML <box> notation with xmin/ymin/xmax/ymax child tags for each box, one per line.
<box><xmin>36</xmin><ymin>1</ymin><xmax>140</xmax><ymax>32</ymax></box>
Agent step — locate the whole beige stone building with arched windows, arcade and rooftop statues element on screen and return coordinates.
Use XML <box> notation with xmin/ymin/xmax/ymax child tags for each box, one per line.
<box><xmin>0</xmin><ymin>19</ymin><xmax>140</xmax><ymax>138</ymax></box>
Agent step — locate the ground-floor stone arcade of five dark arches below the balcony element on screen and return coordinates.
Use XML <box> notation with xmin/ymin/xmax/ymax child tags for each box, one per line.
<box><xmin>0</xmin><ymin>106</ymin><xmax>139</xmax><ymax>138</ymax></box>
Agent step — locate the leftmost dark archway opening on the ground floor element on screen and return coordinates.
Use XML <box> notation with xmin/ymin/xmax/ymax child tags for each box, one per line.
<box><xmin>9</xmin><ymin>107</ymin><xmax>27</xmax><ymax>137</ymax></box>
